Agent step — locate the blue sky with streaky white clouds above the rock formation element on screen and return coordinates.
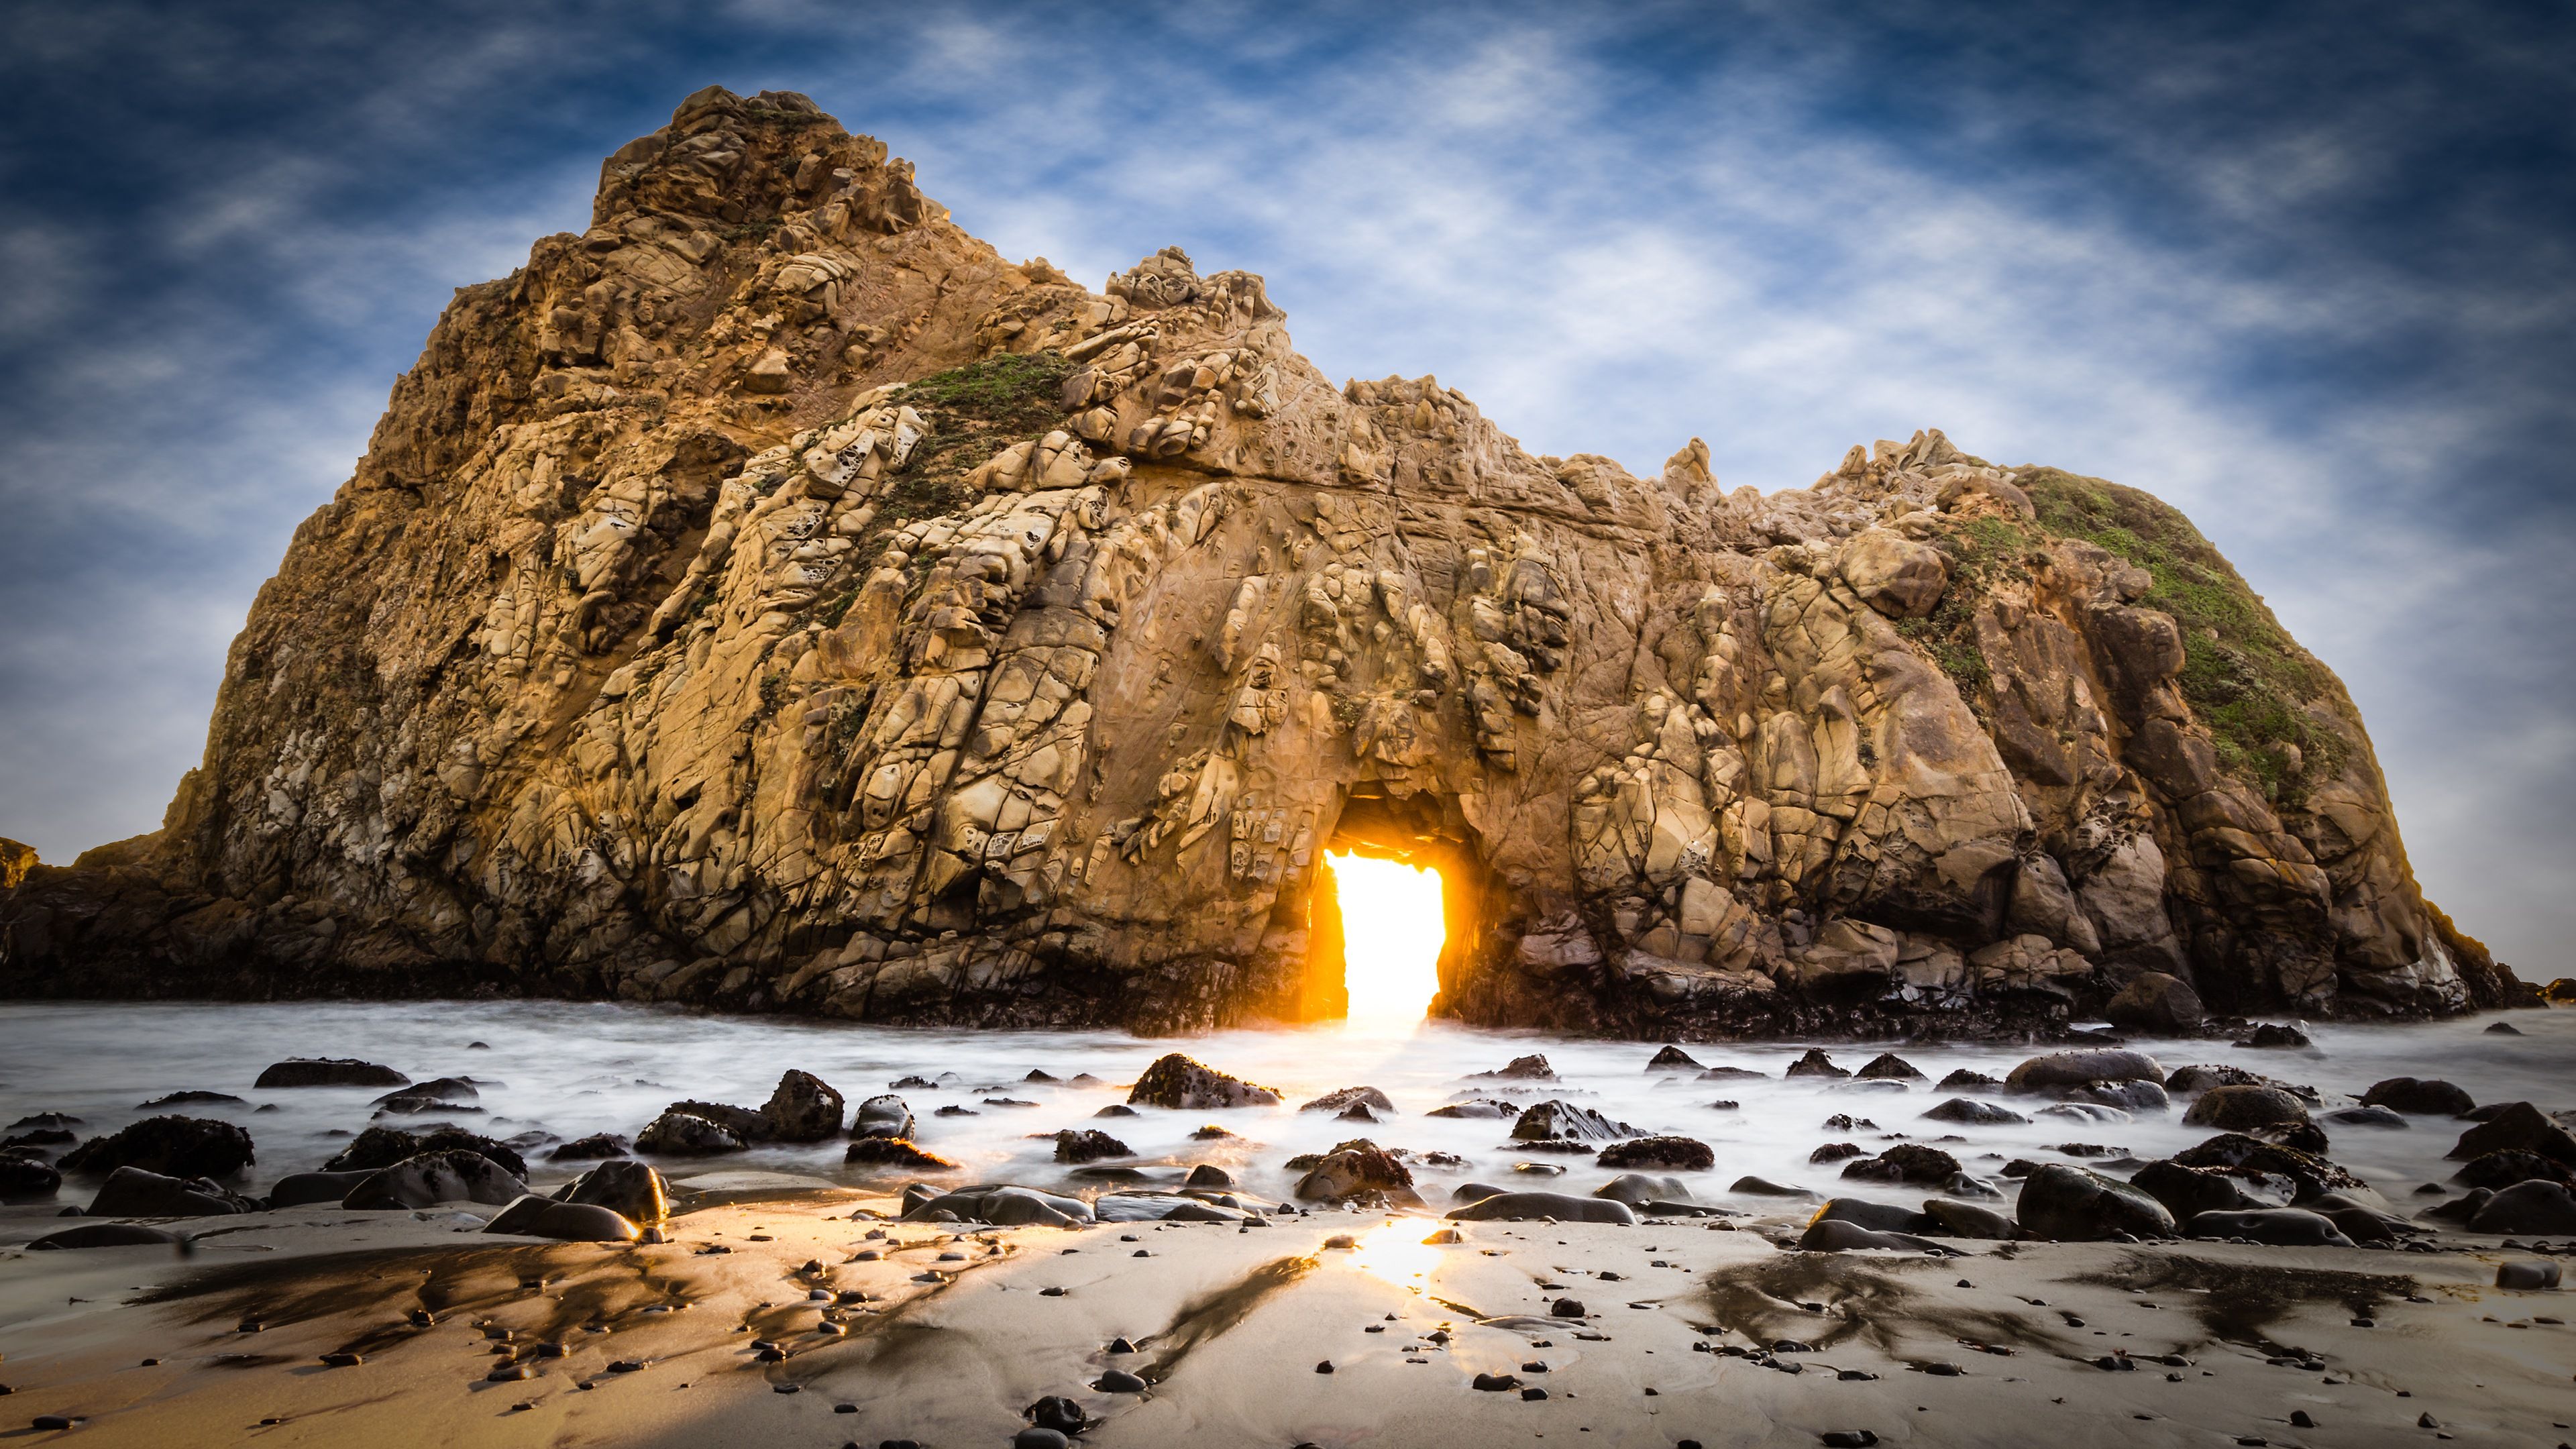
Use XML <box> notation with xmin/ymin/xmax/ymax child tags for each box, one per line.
<box><xmin>0</xmin><ymin>0</ymin><xmax>2576</xmax><ymax>979</ymax></box>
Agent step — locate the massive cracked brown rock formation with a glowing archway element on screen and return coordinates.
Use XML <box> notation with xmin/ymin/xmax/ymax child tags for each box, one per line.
<box><xmin>0</xmin><ymin>88</ymin><xmax>2514</xmax><ymax>1039</ymax></box>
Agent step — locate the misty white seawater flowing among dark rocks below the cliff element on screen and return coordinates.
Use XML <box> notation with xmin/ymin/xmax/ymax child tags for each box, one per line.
<box><xmin>0</xmin><ymin>1000</ymin><xmax>2576</xmax><ymax>1212</ymax></box>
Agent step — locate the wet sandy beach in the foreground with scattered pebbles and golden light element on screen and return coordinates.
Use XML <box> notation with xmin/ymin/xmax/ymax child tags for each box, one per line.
<box><xmin>0</xmin><ymin>1183</ymin><xmax>2576</xmax><ymax>1449</ymax></box>
